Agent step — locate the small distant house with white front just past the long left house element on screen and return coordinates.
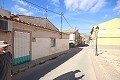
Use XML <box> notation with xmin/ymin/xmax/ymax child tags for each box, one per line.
<box><xmin>62</xmin><ymin>29</ymin><xmax>81</xmax><ymax>47</ymax></box>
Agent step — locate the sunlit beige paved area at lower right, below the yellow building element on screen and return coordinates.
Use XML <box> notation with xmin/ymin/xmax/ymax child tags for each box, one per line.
<box><xmin>96</xmin><ymin>49</ymin><xmax>120</xmax><ymax>80</ymax></box>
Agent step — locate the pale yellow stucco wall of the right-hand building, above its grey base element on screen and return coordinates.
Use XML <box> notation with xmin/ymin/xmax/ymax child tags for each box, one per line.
<box><xmin>92</xmin><ymin>18</ymin><xmax>120</xmax><ymax>46</ymax></box>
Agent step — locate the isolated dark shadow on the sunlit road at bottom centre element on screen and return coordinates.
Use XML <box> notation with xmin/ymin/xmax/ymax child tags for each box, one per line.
<box><xmin>53</xmin><ymin>70</ymin><xmax>85</xmax><ymax>80</ymax></box>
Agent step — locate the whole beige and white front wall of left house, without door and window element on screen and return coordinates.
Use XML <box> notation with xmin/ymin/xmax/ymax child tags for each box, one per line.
<box><xmin>0</xmin><ymin>19</ymin><xmax>69</xmax><ymax>60</ymax></box>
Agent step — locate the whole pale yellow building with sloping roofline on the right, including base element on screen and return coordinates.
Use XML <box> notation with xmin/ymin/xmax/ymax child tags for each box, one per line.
<box><xmin>91</xmin><ymin>18</ymin><xmax>120</xmax><ymax>49</ymax></box>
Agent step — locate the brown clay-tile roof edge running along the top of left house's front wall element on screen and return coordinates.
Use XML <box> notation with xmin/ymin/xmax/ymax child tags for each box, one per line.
<box><xmin>0</xmin><ymin>15</ymin><xmax>59</xmax><ymax>32</ymax></box>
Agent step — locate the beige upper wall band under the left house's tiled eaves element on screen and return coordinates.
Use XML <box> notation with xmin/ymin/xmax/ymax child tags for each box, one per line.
<box><xmin>13</xmin><ymin>22</ymin><xmax>69</xmax><ymax>39</ymax></box>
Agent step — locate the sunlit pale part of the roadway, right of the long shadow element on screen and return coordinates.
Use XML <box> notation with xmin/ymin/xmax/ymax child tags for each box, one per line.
<box><xmin>39</xmin><ymin>47</ymin><xmax>97</xmax><ymax>80</ymax></box>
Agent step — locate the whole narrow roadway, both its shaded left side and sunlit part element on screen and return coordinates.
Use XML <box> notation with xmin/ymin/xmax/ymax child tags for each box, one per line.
<box><xmin>12</xmin><ymin>47</ymin><xmax>96</xmax><ymax>80</ymax></box>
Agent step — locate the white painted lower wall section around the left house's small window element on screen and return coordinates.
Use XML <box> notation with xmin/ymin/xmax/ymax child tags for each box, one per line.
<box><xmin>32</xmin><ymin>38</ymin><xmax>69</xmax><ymax>60</ymax></box>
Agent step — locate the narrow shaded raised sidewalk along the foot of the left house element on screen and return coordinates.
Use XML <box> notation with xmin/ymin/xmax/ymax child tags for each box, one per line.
<box><xmin>12</xmin><ymin>49</ymin><xmax>72</xmax><ymax>75</ymax></box>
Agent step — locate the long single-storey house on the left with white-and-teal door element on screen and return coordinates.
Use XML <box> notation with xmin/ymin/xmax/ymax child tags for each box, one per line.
<box><xmin>0</xmin><ymin>9</ymin><xmax>69</xmax><ymax>65</ymax></box>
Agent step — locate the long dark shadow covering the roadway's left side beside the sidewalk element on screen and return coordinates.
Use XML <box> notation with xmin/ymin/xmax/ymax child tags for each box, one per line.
<box><xmin>12</xmin><ymin>48</ymin><xmax>82</xmax><ymax>80</ymax></box>
